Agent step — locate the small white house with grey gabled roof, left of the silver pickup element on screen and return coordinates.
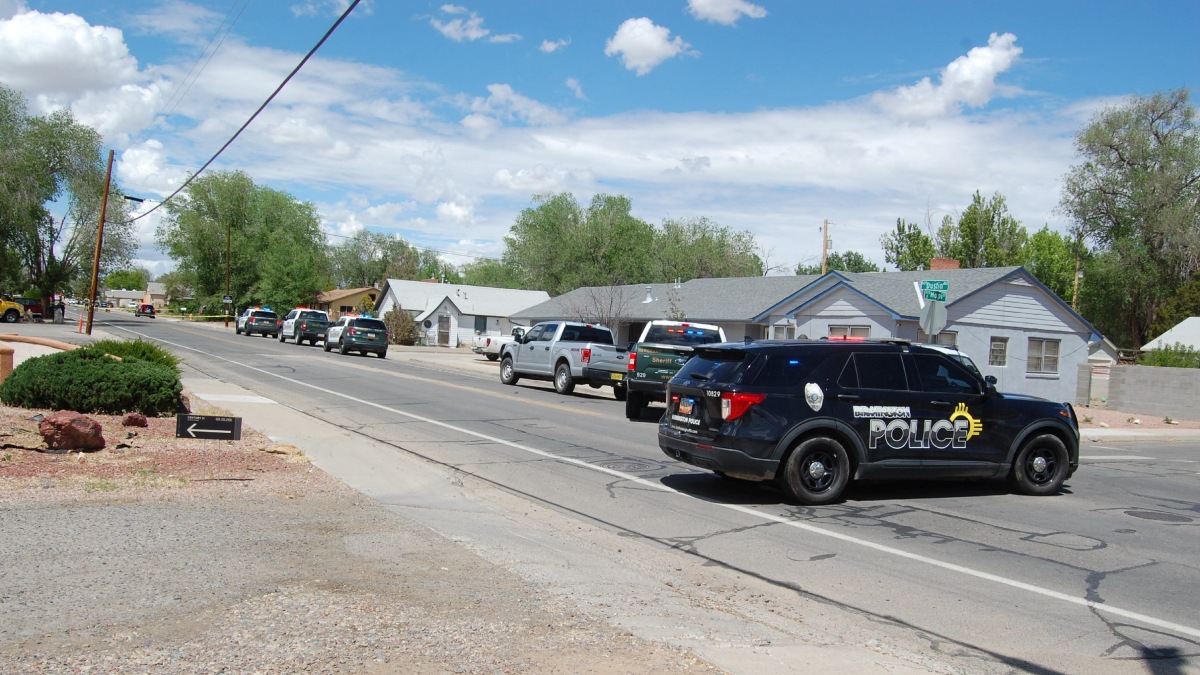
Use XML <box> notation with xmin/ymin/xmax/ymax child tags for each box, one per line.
<box><xmin>376</xmin><ymin>279</ymin><xmax>550</xmax><ymax>347</ymax></box>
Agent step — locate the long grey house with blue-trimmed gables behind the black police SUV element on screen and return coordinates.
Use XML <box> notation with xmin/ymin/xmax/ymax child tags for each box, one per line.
<box><xmin>510</xmin><ymin>267</ymin><xmax>1103</xmax><ymax>401</ymax></box>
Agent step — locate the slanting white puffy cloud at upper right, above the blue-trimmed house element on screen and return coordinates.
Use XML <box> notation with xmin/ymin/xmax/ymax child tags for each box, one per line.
<box><xmin>872</xmin><ymin>32</ymin><xmax>1021</xmax><ymax>119</ymax></box>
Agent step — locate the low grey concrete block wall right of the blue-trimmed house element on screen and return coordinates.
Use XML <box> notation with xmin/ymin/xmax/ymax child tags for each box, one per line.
<box><xmin>1078</xmin><ymin>365</ymin><xmax>1200</xmax><ymax>420</ymax></box>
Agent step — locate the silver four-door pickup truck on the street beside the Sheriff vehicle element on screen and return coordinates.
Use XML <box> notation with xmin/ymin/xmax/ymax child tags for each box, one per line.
<box><xmin>500</xmin><ymin>321</ymin><xmax>629</xmax><ymax>401</ymax></box>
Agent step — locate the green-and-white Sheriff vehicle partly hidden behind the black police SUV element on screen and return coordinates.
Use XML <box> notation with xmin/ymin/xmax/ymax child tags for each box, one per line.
<box><xmin>625</xmin><ymin>321</ymin><xmax>725</xmax><ymax>419</ymax></box>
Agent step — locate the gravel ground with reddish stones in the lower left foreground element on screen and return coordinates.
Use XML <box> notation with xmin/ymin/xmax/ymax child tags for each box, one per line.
<box><xmin>0</xmin><ymin>407</ymin><xmax>716</xmax><ymax>674</ymax></box>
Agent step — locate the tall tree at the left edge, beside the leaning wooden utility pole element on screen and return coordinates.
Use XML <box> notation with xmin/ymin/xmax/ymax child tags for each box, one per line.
<box><xmin>0</xmin><ymin>84</ymin><xmax>137</xmax><ymax>299</ymax></box>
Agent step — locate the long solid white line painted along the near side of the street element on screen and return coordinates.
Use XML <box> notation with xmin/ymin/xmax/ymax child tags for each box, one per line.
<box><xmin>136</xmin><ymin>336</ymin><xmax>1200</xmax><ymax>638</ymax></box>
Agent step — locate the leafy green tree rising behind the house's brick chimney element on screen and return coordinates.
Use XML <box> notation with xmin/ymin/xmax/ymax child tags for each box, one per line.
<box><xmin>937</xmin><ymin>191</ymin><xmax>1028</xmax><ymax>268</ymax></box>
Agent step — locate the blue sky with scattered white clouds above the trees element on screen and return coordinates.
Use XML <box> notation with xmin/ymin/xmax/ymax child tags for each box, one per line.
<box><xmin>0</xmin><ymin>0</ymin><xmax>1200</xmax><ymax>275</ymax></box>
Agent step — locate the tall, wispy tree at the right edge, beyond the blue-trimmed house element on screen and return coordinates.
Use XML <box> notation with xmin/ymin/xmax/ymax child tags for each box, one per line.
<box><xmin>1061</xmin><ymin>89</ymin><xmax>1200</xmax><ymax>347</ymax></box>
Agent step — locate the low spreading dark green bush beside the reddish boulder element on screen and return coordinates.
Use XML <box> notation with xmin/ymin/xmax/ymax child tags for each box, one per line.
<box><xmin>0</xmin><ymin>347</ymin><xmax>184</xmax><ymax>416</ymax></box>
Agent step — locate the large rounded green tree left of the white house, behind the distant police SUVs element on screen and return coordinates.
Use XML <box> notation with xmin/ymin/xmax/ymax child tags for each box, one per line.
<box><xmin>157</xmin><ymin>172</ymin><xmax>330</xmax><ymax>307</ymax></box>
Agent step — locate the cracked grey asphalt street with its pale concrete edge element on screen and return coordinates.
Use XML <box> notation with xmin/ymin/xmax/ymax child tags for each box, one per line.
<box><xmin>21</xmin><ymin>316</ymin><xmax>1200</xmax><ymax>673</ymax></box>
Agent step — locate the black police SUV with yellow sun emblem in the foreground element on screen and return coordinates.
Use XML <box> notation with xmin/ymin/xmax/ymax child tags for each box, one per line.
<box><xmin>659</xmin><ymin>340</ymin><xmax>1079</xmax><ymax>504</ymax></box>
